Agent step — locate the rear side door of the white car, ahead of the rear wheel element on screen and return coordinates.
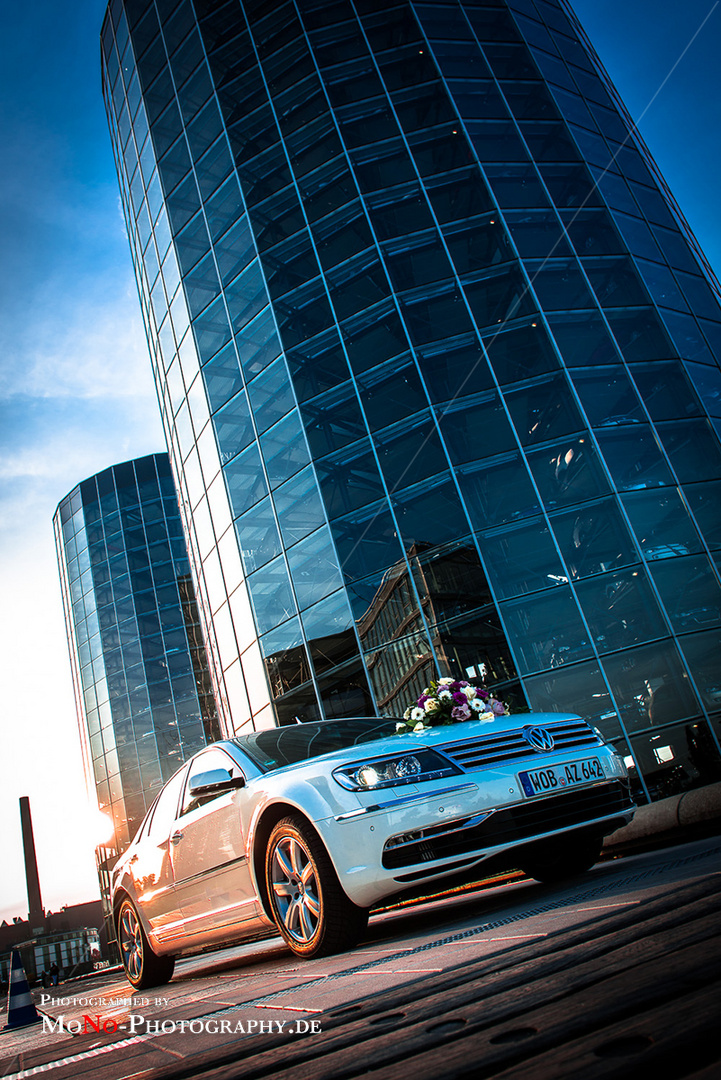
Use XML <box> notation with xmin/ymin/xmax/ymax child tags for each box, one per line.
<box><xmin>128</xmin><ymin>767</ymin><xmax>188</xmax><ymax>942</ymax></box>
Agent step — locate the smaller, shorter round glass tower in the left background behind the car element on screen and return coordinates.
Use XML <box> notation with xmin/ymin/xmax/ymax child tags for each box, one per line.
<box><xmin>53</xmin><ymin>454</ymin><xmax>220</xmax><ymax>915</ymax></box>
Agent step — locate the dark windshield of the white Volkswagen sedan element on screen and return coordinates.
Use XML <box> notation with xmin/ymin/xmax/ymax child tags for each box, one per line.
<box><xmin>232</xmin><ymin>716</ymin><xmax>398</xmax><ymax>772</ymax></box>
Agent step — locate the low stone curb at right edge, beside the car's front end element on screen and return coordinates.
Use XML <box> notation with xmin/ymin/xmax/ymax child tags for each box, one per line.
<box><xmin>603</xmin><ymin>783</ymin><xmax>721</xmax><ymax>850</ymax></box>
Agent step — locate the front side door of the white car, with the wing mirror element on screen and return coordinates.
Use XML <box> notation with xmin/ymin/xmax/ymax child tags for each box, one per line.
<box><xmin>171</xmin><ymin>747</ymin><xmax>258</xmax><ymax>941</ymax></box>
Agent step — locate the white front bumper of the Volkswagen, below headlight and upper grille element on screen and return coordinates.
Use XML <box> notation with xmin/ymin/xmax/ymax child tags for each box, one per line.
<box><xmin>316</xmin><ymin>746</ymin><xmax>635</xmax><ymax>907</ymax></box>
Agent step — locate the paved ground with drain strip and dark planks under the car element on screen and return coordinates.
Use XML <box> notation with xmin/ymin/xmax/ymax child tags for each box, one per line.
<box><xmin>0</xmin><ymin>837</ymin><xmax>721</xmax><ymax>1080</ymax></box>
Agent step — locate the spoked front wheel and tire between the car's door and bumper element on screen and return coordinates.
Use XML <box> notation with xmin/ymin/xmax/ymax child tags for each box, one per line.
<box><xmin>266</xmin><ymin>816</ymin><xmax>368</xmax><ymax>959</ymax></box>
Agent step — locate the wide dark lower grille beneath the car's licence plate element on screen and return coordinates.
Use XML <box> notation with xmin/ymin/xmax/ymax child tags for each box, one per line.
<box><xmin>381</xmin><ymin>781</ymin><xmax>634</xmax><ymax>880</ymax></box>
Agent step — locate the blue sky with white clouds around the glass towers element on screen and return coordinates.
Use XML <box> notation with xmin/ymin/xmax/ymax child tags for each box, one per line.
<box><xmin>0</xmin><ymin>0</ymin><xmax>721</xmax><ymax>920</ymax></box>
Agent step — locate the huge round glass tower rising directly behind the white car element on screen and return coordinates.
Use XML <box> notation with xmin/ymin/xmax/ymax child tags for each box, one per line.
<box><xmin>101</xmin><ymin>0</ymin><xmax>721</xmax><ymax>799</ymax></box>
